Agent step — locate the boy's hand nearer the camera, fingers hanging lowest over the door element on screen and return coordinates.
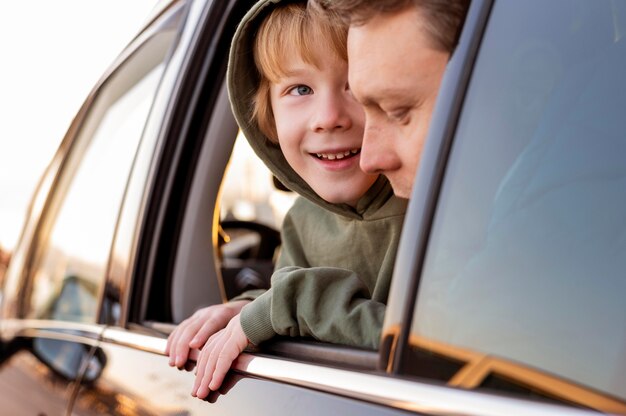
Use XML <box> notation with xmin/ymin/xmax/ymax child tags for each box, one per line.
<box><xmin>191</xmin><ymin>315</ymin><xmax>248</xmax><ymax>399</ymax></box>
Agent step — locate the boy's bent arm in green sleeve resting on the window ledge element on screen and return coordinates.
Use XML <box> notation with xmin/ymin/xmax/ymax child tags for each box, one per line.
<box><xmin>241</xmin><ymin>266</ymin><xmax>386</xmax><ymax>349</ymax></box>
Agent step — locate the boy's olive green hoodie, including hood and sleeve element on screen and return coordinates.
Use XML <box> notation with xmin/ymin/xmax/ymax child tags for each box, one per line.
<box><xmin>227</xmin><ymin>0</ymin><xmax>406</xmax><ymax>349</ymax></box>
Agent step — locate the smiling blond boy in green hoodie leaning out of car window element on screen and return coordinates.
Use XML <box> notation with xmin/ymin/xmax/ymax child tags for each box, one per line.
<box><xmin>168</xmin><ymin>0</ymin><xmax>406</xmax><ymax>398</ymax></box>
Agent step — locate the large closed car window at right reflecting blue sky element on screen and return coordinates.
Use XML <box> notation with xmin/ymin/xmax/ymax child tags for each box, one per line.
<box><xmin>401</xmin><ymin>0</ymin><xmax>626</xmax><ymax>414</ymax></box>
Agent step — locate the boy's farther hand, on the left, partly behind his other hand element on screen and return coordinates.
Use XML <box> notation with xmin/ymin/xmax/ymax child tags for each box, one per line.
<box><xmin>165</xmin><ymin>300</ymin><xmax>250</xmax><ymax>368</ymax></box>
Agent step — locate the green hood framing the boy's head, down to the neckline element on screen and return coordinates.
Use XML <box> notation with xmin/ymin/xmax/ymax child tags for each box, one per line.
<box><xmin>227</xmin><ymin>0</ymin><xmax>393</xmax><ymax>219</ymax></box>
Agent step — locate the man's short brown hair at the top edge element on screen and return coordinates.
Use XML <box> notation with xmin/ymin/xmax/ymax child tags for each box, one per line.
<box><xmin>311</xmin><ymin>0</ymin><xmax>470</xmax><ymax>53</ymax></box>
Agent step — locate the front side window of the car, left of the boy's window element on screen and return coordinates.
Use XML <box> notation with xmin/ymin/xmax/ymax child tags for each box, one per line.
<box><xmin>26</xmin><ymin>22</ymin><xmax>179</xmax><ymax>322</ymax></box>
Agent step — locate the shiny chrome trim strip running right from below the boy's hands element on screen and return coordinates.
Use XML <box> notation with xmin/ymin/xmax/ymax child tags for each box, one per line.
<box><xmin>232</xmin><ymin>354</ymin><xmax>598</xmax><ymax>416</ymax></box>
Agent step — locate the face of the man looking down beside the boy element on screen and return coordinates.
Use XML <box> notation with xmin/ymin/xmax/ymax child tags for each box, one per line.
<box><xmin>348</xmin><ymin>7</ymin><xmax>449</xmax><ymax>198</ymax></box>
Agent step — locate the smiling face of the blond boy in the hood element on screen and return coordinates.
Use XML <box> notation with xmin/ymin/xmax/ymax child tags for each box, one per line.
<box><xmin>270</xmin><ymin>52</ymin><xmax>378</xmax><ymax>206</ymax></box>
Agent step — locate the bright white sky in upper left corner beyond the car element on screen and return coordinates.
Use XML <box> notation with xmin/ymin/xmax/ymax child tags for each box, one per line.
<box><xmin>0</xmin><ymin>0</ymin><xmax>157</xmax><ymax>251</ymax></box>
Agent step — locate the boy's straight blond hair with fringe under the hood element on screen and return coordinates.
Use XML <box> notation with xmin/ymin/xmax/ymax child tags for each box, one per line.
<box><xmin>252</xmin><ymin>2</ymin><xmax>348</xmax><ymax>142</ymax></box>
